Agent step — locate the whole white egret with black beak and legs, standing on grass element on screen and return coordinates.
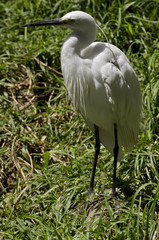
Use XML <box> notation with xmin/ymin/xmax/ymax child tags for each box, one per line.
<box><xmin>23</xmin><ymin>11</ymin><xmax>141</xmax><ymax>195</ymax></box>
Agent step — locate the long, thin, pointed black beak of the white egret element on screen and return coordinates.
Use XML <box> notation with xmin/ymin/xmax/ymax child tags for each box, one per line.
<box><xmin>21</xmin><ymin>18</ymin><xmax>62</xmax><ymax>27</ymax></box>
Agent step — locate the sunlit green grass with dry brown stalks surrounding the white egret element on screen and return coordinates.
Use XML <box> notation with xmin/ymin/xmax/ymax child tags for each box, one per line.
<box><xmin>0</xmin><ymin>0</ymin><xmax>159</xmax><ymax>240</ymax></box>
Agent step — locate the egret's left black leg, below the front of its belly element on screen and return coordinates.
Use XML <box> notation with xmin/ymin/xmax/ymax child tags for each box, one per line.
<box><xmin>88</xmin><ymin>125</ymin><xmax>100</xmax><ymax>195</ymax></box>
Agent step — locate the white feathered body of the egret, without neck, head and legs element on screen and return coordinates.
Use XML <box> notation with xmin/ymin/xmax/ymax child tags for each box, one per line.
<box><xmin>63</xmin><ymin>40</ymin><xmax>141</xmax><ymax>158</ymax></box>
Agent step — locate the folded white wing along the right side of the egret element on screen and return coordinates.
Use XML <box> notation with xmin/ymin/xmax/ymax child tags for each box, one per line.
<box><xmin>101</xmin><ymin>45</ymin><xmax>141</xmax><ymax>149</ymax></box>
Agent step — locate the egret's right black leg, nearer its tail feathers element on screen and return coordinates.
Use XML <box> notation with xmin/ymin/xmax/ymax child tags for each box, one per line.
<box><xmin>111</xmin><ymin>123</ymin><xmax>119</xmax><ymax>196</ymax></box>
